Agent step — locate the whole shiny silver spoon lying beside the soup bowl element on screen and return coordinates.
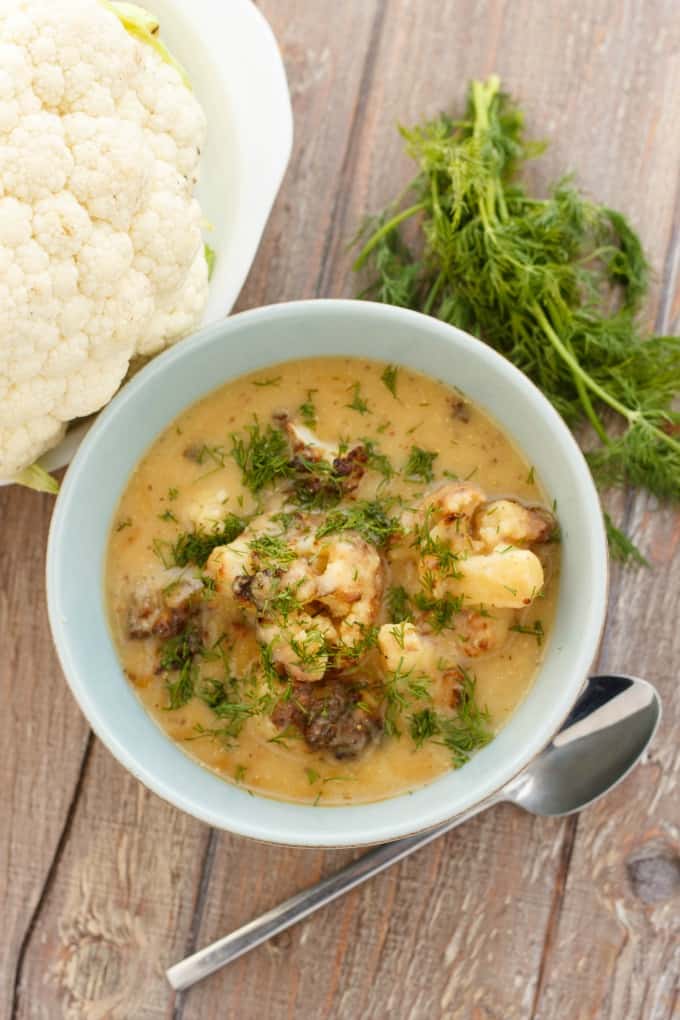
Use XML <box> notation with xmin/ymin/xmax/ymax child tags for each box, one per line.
<box><xmin>166</xmin><ymin>675</ymin><xmax>661</xmax><ymax>988</ymax></box>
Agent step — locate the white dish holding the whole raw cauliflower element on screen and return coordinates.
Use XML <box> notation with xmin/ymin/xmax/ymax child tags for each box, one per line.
<box><xmin>0</xmin><ymin>0</ymin><xmax>293</xmax><ymax>485</ymax></box>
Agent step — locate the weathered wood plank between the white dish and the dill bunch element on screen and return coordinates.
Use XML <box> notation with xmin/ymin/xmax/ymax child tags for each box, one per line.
<box><xmin>238</xmin><ymin>0</ymin><xmax>382</xmax><ymax>309</ymax></box>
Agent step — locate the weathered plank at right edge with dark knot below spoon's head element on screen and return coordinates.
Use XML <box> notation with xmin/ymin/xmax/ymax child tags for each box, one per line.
<box><xmin>532</xmin><ymin>381</ymin><xmax>680</xmax><ymax>1020</ymax></box>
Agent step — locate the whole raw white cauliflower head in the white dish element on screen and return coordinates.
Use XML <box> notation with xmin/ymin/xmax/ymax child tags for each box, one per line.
<box><xmin>0</xmin><ymin>0</ymin><xmax>208</xmax><ymax>477</ymax></box>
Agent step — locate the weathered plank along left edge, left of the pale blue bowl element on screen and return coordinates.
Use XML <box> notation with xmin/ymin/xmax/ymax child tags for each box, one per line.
<box><xmin>0</xmin><ymin>488</ymin><xmax>89</xmax><ymax>1017</ymax></box>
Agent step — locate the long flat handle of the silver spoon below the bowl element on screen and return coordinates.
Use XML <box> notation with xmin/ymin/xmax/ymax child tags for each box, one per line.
<box><xmin>165</xmin><ymin>798</ymin><xmax>500</xmax><ymax>989</ymax></box>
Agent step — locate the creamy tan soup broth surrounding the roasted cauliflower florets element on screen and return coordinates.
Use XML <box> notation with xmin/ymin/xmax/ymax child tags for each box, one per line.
<box><xmin>106</xmin><ymin>358</ymin><xmax>559</xmax><ymax>805</ymax></box>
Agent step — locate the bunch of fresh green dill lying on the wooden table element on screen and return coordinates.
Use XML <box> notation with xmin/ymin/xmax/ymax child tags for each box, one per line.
<box><xmin>355</xmin><ymin>77</ymin><xmax>680</xmax><ymax>558</ymax></box>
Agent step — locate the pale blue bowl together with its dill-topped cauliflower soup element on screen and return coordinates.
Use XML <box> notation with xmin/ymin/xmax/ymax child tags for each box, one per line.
<box><xmin>48</xmin><ymin>302</ymin><xmax>607</xmax><ymax>845</ymax></box>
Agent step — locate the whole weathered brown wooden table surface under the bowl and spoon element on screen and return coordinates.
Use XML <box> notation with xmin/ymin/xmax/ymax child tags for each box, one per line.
<box><xmin>0</xmin><ymin>0</ymin><xmax>680</xmax><ymax>1020</ymax></box>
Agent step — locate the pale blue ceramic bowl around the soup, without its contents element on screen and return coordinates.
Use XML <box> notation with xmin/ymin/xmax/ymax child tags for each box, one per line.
<box><xmin>47</xmin><ymin>301</ymin><xmax>608</xmax><ymax>847</ymax></box>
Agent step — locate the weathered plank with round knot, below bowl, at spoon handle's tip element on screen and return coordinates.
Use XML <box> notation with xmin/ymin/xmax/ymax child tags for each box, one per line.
<box><xmin>14</xmin><ymin>742</ymin><xmax>210</xmax><ymax>1020</ymax></box>
